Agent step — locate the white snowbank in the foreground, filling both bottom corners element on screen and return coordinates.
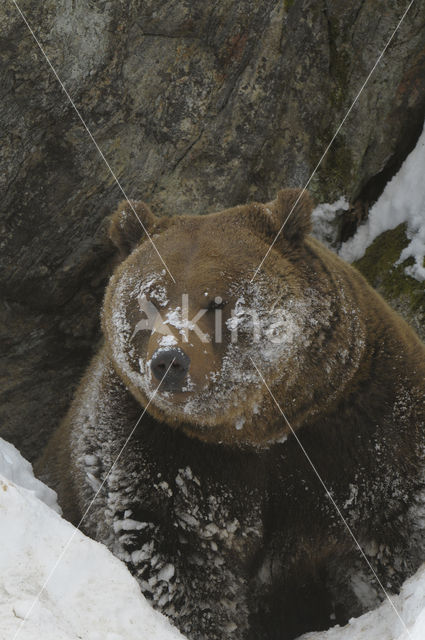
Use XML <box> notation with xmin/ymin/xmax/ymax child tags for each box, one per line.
<box><xmin>0</xmin><ymin>439</ymin><xmax>425</xmax><ymax>640</ymax></box>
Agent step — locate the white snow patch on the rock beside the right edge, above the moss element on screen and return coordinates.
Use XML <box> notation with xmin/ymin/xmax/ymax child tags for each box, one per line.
<box><xmin>338</xmin><ymin>120</ymin><xmax>425</xmax><ymax>280</ymax></box>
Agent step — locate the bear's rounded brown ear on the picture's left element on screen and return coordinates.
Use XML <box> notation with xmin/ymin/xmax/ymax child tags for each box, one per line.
<box><xmin>109</xmin><ymin>200</ymin><xmax>158</xmax><ymax>258</ymax></box>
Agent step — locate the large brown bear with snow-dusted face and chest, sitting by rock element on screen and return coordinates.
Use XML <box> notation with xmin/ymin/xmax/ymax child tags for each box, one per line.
<box><xmin>38</xmin><ymin>189</ymin><xmax>425</xmax><ymax>640</ymax></box>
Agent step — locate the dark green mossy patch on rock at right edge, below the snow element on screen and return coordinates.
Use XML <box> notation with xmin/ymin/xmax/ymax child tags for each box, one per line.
<box><xmin>354</xmin><ymin>224</ymin><xmax>425</xmax><ymax>319</ymax></box>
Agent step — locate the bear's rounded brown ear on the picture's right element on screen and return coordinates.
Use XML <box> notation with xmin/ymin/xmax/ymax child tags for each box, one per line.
<box><xmin>266</xmin><ymin>189</ymin><xmax>313</xmax><ymax>243</ymax></box>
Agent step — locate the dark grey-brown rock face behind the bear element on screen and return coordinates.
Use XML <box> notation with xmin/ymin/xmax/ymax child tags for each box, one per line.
<box><xmin>0</xmin><ymin>0</ymin><xmax>425</xmax><ymax>459</ymax></box>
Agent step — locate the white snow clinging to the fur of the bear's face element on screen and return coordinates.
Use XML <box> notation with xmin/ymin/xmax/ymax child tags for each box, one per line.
<box><xmin>110</xmin><ymin>273</ymin><xmax>342</xmax><ymax>428</ymax></box>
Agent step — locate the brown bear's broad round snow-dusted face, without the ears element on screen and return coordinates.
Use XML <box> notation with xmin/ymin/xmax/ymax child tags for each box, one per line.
<box><xmin>103</xmin><ymin>192</ymin><xmax>364</xmax><ymax>444</ymax></box>
